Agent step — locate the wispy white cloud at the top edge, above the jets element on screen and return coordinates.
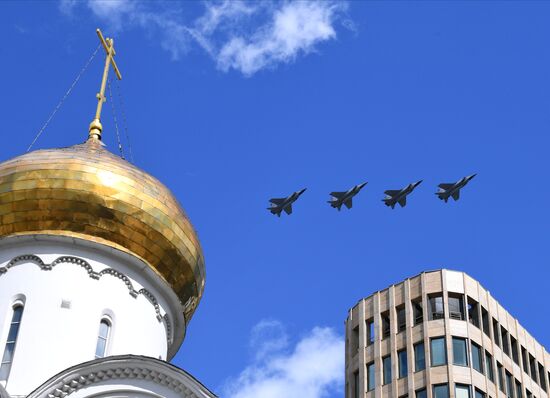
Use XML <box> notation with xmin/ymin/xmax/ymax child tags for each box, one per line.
<box><xmin>59</xmin><ymin>0</ymin><xmax>351</xmax><ymax>76</ymax></box>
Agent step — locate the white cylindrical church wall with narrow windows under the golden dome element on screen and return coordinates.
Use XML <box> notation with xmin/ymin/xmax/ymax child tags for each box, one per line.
<box><xmin>0</xmin><ymin>235</ymin><xmax>179</xmax><ymax>395</ymax></box>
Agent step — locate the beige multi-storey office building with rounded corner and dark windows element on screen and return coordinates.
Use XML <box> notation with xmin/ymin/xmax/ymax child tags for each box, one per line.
<box><xmin>346</xmin><ymin>270</ymin><xmax>550</xmax><ymax>398</ymax></box>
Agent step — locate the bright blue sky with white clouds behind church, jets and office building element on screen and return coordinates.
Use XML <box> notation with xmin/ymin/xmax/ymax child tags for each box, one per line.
<box><xmin>0</xmin><ymin>1</ymin><xmax>550</xmax><ymax>398</ymax></box>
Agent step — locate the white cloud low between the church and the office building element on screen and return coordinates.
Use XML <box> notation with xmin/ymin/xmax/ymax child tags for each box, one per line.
<box><xmin>223</xmin><ymin>321</ymin><xmax>344</xmax><ymax>398</ymax></box>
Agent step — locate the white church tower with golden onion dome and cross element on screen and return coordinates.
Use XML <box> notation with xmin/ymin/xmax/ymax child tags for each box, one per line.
<box><xmin>0</xmin><ymin>30</ymin><xmax>215</xmax><ymax>398</ymax></box>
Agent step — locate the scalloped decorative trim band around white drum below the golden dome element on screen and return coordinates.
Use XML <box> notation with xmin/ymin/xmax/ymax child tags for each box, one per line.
<box><xmin>0</xmin><ymin>254</ymin><xmax>173</xmax><ymax>345</ymax></box>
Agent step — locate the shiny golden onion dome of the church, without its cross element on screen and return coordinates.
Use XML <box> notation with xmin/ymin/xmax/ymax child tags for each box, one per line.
<box><xmin>0</xmin><ymin>138</ymin><xmax>205</xmax><ymax>321</ymax></box>
